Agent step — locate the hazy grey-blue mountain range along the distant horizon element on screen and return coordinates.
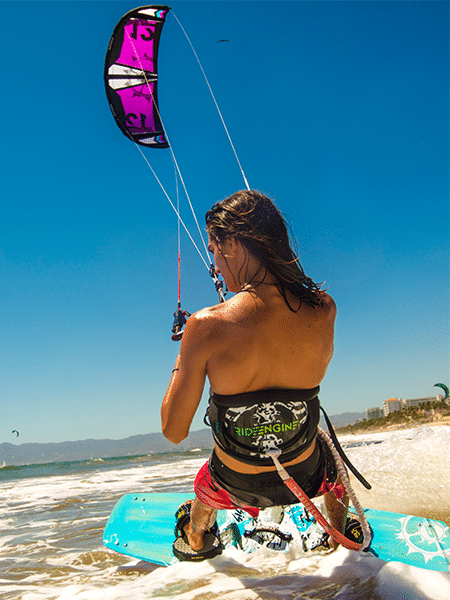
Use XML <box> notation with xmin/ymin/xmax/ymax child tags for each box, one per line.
<box><xmin>0</xmin><ymin>413</ymin><xmax>365</xmax><ymax>466</ymax></box>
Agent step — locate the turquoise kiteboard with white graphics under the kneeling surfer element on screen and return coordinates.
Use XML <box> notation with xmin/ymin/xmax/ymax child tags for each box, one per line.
<box><xmin>103</xmin><ymin>493</ymin><xmax>450</xmax><ymax>571</ymax></box>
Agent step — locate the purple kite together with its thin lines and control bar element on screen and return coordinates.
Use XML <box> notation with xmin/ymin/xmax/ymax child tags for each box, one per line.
<box><xmin>104</xmin><ymin>6</ymin><xmax>250</xmax><ymax>339</ymax></box>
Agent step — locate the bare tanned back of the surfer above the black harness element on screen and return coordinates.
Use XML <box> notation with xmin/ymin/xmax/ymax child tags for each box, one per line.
<box><xmin>199</xmin><ymin>284</ymin><xmax>336</xmax><ymax>394</ymax></box>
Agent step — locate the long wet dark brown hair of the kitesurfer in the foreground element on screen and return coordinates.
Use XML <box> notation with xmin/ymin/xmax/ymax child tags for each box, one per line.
<box><xmin>205</xmin><ymin>190</ymin><xmax>322</xmax><ymax>312</ymax></box>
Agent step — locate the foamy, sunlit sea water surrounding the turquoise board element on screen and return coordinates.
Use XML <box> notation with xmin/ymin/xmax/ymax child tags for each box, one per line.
<box><xmin>0</xmin><ymin>426</ymin><xmax>450</xmax><ymax>600</ymax></box>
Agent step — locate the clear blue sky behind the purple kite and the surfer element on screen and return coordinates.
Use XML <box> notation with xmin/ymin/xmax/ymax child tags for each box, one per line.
<box><xmin>0</xmin><ymin>0</ymin><xmax>450</xmax><ymax>443</ymax></box>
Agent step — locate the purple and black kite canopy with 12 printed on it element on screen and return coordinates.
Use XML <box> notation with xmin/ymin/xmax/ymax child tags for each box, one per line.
<box><xmin>104</xmin><ymin>6</ymin><xmax>170</xmax><ymax>148</ymax></box>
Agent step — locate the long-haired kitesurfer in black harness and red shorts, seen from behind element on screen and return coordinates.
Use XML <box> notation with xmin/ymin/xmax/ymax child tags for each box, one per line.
<box><xmin>161</xmin><ymin>191</ymin><xmax>348</xmax><ymax>560</ymax></box>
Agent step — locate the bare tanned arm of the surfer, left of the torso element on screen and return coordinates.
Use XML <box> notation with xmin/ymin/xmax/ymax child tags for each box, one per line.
<box><xmin>161</xmin><ymin>313</ymin><xmax>209</xmax><ymax>444</ymax></box>
